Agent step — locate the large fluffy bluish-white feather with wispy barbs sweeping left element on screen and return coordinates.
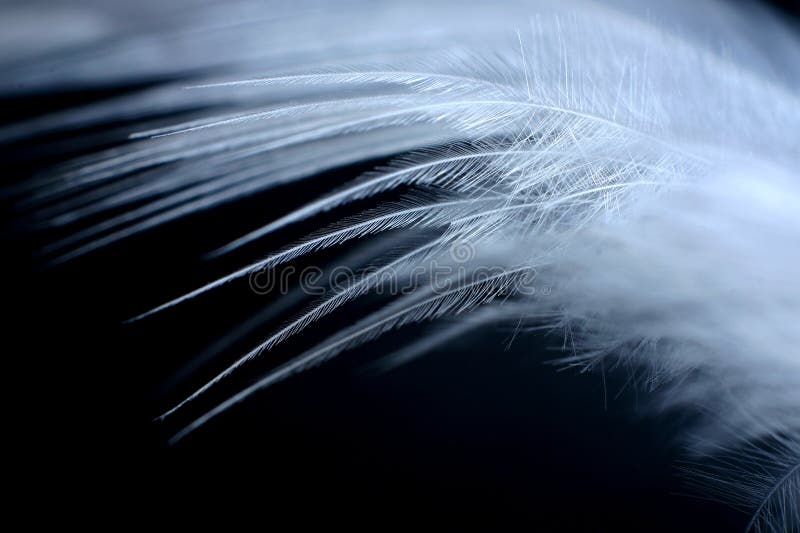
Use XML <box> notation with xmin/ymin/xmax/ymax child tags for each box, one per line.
<box><xmin>6</xmin><ymin>0</ymin><xmax>800</xmax><ymax>531</ymax></box>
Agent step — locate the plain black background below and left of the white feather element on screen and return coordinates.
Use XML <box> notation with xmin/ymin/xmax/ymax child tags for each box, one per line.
<box><xmin>0</xmin><ymin>2</ymin><xmax>798</xmax><ymax>531</ymax></box>
